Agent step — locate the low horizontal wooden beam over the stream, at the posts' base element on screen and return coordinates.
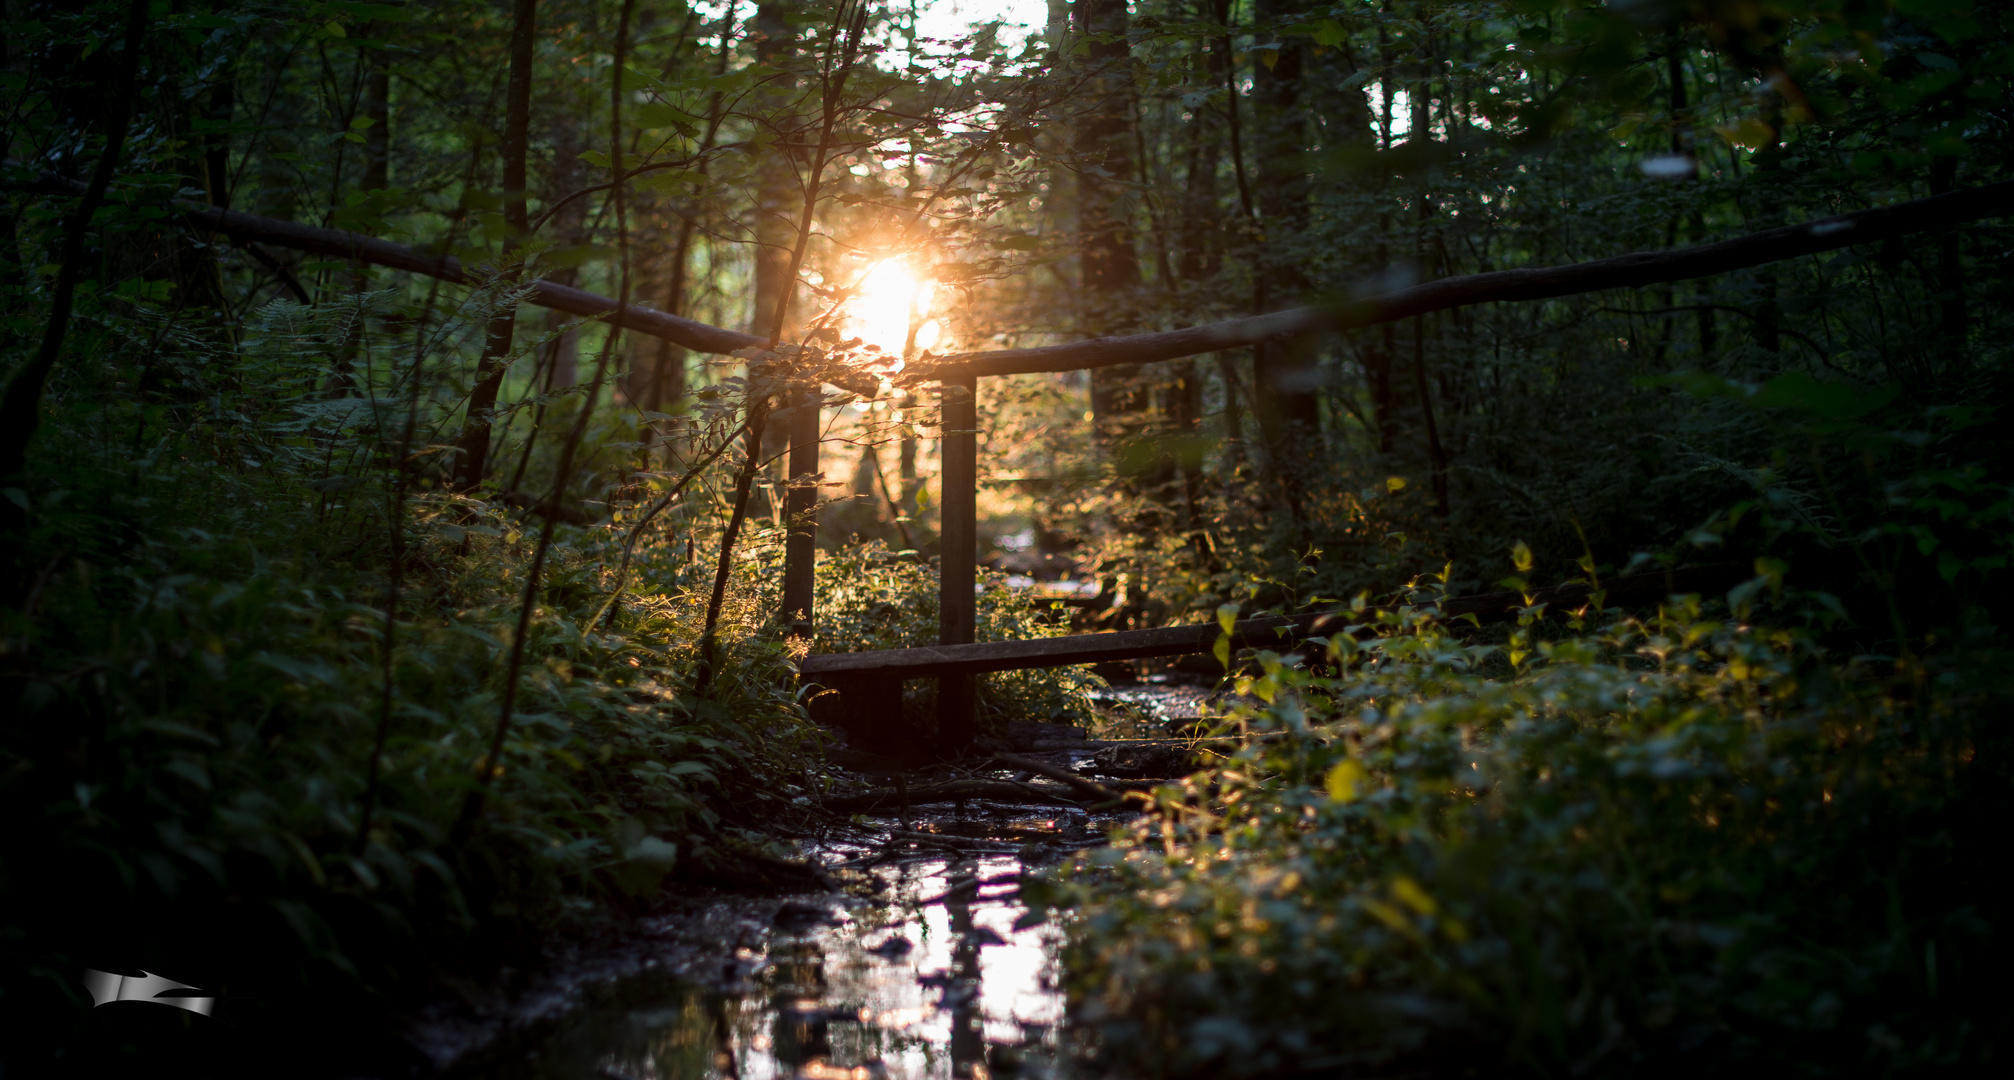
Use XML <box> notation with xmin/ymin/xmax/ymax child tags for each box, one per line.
<box><xmin>798</xmin><ymin>564</ymin><xmax>1750</xmax><ymax>679</ymax></box>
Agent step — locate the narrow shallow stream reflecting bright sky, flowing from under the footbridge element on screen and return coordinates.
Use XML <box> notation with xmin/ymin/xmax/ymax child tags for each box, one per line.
<box><xmin>455</xmin><ymin>683</ymin><xmax>1200</xmax><ymax>1080</ymax></box>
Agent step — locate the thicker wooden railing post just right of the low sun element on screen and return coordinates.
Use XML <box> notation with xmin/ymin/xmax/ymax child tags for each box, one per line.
<box><xmin>937</xmin><ymin>375</ymin><xmax>979</xmax><ymax>754</ymax></box>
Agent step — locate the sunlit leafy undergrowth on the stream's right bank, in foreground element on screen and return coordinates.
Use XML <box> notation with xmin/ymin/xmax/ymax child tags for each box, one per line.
<box><xmin>1045</xmin><ymin>590</ymin><xmax>2010</xmax><ymax>1076</ymax></box>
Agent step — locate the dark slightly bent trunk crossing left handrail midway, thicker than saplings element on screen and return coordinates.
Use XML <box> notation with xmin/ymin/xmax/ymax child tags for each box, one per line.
<box><xmin>455</xmin><ymin>0</ymin><xmax>535</xmax><ymax>490</ymax></box>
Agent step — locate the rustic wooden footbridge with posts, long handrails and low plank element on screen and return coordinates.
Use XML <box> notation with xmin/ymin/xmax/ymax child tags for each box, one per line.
<box><xmin>117</xmin><ymin>175</ymin><xmax>2014</xmax><ymax>754</ymax></box>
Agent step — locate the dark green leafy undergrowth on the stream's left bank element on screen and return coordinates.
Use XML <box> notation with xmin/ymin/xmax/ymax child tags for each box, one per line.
<box><xmin>0</xmin><ymin>298</ymin><xmax>833</xmax><ymax>1070</ymax></box>
